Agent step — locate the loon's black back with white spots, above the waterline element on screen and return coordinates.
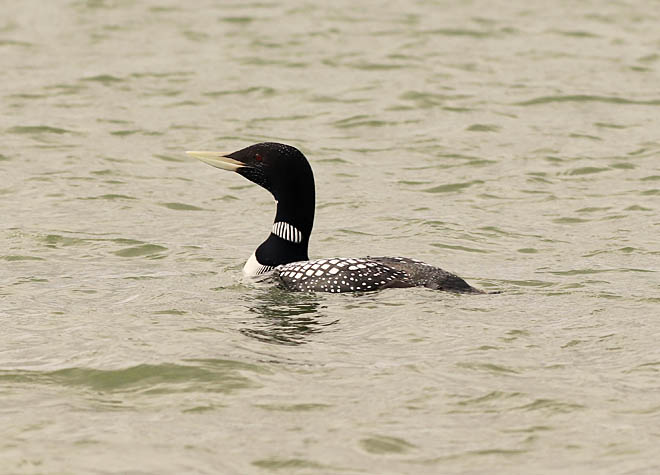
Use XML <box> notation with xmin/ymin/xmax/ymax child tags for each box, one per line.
<box><xmin>275</xmin><ymin>257</ymin><xmax>477</xmax><ymax>293</ymax></box>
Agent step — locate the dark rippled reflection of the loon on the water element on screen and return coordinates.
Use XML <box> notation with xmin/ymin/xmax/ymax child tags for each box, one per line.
<box><xmin>240</xmin><ymin>287</ymin><xmax>337</xmax><ymax>345</ymax></box>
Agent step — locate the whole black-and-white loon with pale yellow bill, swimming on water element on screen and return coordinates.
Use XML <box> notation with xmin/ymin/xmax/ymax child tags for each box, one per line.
<box><xmin>186</xmin><ymin>142</ymin><xmax>483</xmax><ymax>293</ymax></box>
